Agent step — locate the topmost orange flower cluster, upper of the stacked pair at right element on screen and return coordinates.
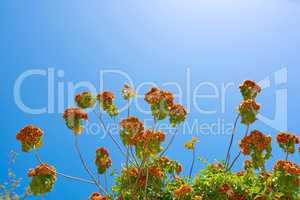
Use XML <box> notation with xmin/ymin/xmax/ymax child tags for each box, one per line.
<box><xmin>240</xmin><ymin>80</ymin><xmax>261</xmax><ymax>100</ymax></box>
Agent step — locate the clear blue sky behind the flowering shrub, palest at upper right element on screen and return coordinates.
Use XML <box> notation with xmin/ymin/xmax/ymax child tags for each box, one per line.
<box><xmin>0</xmin><ymin>0</ymin><xmax>300</xmax><ymax>199</ymax></box>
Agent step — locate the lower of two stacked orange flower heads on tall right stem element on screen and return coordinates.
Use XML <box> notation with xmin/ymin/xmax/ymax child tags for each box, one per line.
<box><xmin>238</xmin><ymin>99</ymin><xmax>260</xmax><ymax>125</ymax></box>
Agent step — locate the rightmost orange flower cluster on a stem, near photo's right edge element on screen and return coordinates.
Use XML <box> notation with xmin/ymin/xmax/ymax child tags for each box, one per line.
<box><xmin>276</xmin><ymin>133</ymin><xmax>299</xmax><ymax>154</ymax></box>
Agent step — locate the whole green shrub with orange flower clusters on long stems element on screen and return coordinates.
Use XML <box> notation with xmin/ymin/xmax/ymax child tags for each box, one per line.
<box><xmin>17</xmin><ymin>80</ymin><xmax>300</xmax><ymax>200</ymax></box>
